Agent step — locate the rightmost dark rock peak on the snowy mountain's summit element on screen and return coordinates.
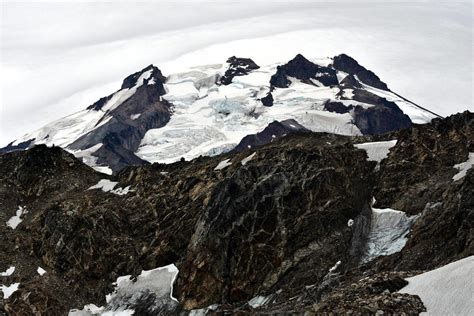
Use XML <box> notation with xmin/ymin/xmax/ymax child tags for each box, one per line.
<box><xmin>333</xmin><ymin>54</ymin><xmax>388</xmax><ymax>90</ymax></box>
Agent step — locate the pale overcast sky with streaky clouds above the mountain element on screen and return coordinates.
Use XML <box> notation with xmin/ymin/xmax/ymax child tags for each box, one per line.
<box><xmin>0</xmin><ymin>0</ymin><xmax>473</xmax><ymax>145</ymax></box>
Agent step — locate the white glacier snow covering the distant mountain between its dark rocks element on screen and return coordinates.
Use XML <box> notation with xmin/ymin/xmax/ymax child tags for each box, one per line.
<box><xmin>7</xmin><ymin>58</ymin><xmax>434</xmax><ymax>170</ymax></box>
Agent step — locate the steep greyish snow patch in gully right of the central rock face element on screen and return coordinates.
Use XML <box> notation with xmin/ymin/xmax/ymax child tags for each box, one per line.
<box><xmin>362</xmin><ymin>208</ymin><xmax>418</xmax><ymax>262</ymax></box>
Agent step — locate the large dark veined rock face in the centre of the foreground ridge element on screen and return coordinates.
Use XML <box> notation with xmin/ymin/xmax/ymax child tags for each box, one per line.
<box><xmin>176</xmin><ymin>138</ymin><xmax>371</xmax><ymax>308</ymax></box>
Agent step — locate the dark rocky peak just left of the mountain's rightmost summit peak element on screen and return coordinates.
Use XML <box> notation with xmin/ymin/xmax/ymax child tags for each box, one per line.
<box><xmin>270</xmin><ymin>54</ymin><xmax>339</xmax><ymax>88</ymax></box>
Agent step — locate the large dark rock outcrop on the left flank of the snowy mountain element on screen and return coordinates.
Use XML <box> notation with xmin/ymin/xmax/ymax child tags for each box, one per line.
<box><xmin>68</xmin><ymin>65</ymin><xmax>172</xmax><ymax>172</ymax></box>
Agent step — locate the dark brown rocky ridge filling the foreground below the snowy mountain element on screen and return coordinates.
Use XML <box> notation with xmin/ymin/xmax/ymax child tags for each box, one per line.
<box><xmin>0</xmin><ymin>112</ymin><xmax>474</xmax><ymax>315</ymax></box>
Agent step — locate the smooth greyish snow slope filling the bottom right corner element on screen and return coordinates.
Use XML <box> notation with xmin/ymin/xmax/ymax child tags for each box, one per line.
<box><xmin>399</xmin><ymin>256</ymin><xmax>474</xmax><ymax>315</ymax></box>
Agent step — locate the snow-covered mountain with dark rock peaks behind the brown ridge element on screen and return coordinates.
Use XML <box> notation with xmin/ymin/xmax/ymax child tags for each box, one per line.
<box><xmin>1</xmin><ymin>54</ymin><xmax>437</xmax><ymax>173</ymax></box>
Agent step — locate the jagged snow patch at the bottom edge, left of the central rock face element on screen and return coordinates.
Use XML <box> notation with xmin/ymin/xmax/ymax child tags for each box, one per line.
<box><xmin>69</xmin><ymin>264</ymin><xmax>179</xmax><ymax>316</ymax></box>
